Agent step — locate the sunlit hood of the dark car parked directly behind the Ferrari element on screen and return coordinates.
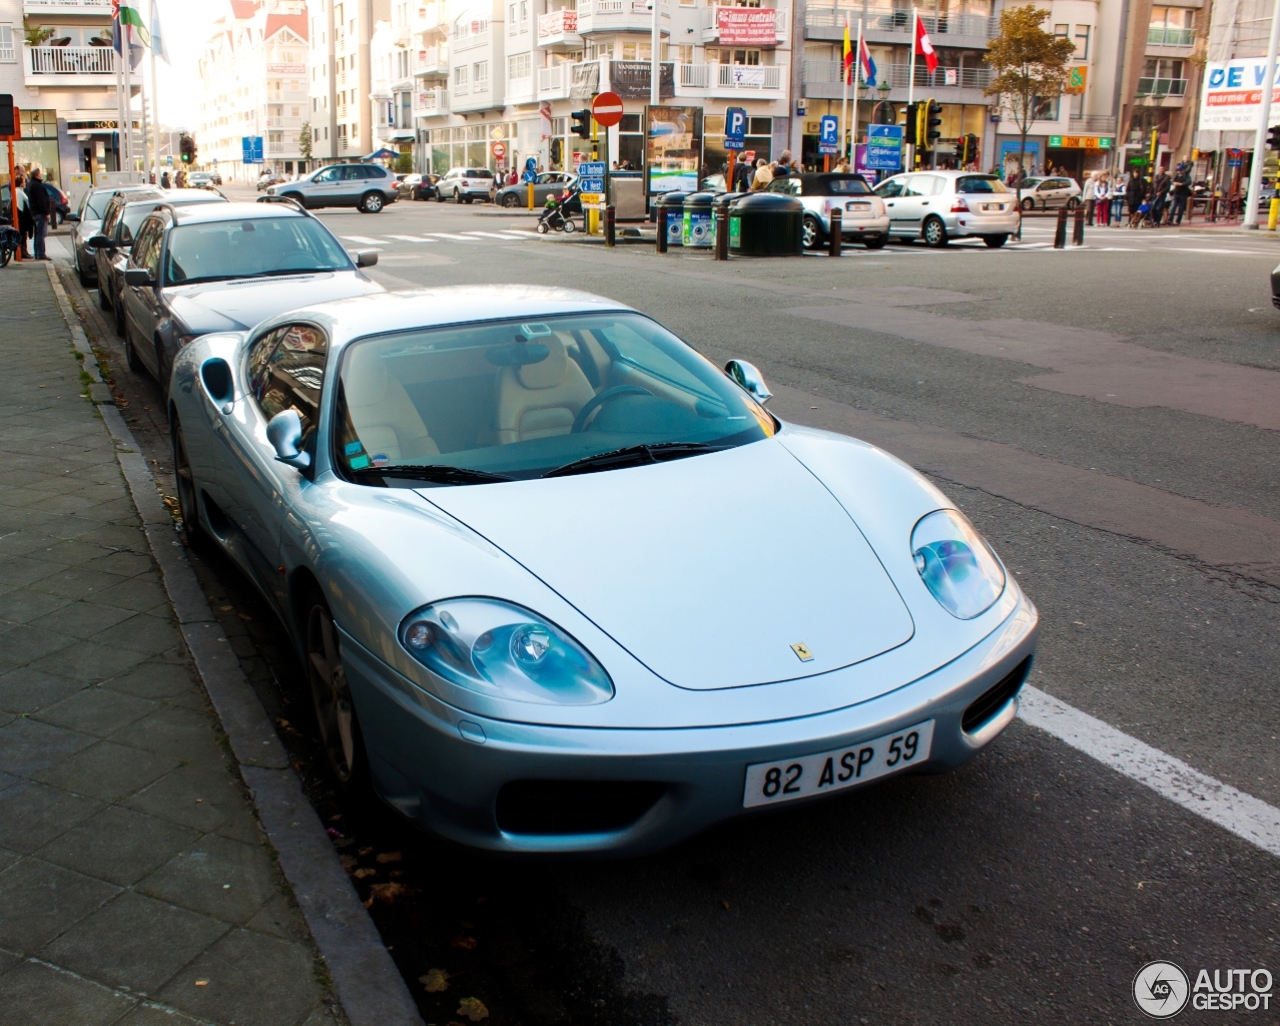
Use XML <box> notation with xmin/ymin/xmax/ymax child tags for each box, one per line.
<box><xmin>165</xmin><ymin>271</ymin><xmax>384</xmax><ymax>335</ymax></box>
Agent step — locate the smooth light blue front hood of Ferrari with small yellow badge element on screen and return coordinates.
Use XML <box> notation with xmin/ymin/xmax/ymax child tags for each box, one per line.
<box><xmin>419</xmin><ymin>440</ymin><xmax>915</xmax><ymax>690</ymax></box>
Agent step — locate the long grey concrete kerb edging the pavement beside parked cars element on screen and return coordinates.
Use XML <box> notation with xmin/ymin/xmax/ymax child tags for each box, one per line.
<box><xmin>49</xmin><ymin>265</ymin><xmax>422</xmax><ymax>1026</ymax></box>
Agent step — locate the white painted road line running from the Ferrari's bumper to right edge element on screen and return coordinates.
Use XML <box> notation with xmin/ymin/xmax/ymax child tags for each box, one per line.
<box><xmin>1018</xmin><ymin>686</ymin><xmax>1280</xmax><ymax>856</ymax></box>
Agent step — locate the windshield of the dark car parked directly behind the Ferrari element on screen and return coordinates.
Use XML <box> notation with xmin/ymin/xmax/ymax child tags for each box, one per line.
<box><xmin>165</xmin><ymin>217</ymin><xmax>352</xmax><ymax>285</ymax></box>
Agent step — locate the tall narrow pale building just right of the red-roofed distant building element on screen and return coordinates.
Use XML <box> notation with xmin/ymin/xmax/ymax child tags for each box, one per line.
<box><xmin>306</xmin><ymin>0</ymin><xmax>390</xmax><ymax>162</ymax></box>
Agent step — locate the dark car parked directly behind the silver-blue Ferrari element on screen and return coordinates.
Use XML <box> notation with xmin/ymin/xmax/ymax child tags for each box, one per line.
<box><xmin>119</xmin><ymin>202</ymin><xmax>383</xmax><ymax>391</ymax></box>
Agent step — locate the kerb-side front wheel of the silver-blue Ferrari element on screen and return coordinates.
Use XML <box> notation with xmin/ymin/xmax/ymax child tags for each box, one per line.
<box><xmin>306</xmin><ymin>592</ymin><xmax>369</xmax><ymax>789</ymax></box>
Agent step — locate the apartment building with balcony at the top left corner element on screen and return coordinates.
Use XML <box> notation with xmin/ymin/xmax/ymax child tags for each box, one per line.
<box><xmin>0</xmin><ymin>0</ymin><xmax>137</xmax><ymax>183</ymax></box>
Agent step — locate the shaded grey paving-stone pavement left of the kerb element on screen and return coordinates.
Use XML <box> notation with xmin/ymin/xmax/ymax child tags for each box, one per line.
<box><xmin>0</xmin><ymin>264</ymin><xmax>344</xmax><ymax>1026</ymax></box>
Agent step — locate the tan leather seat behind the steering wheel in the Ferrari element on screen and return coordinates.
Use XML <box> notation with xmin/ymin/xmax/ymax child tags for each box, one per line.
<box><xmin>498</xmin><ymin>335</ymin><xmax>595</xmax><ymax>445</ymax></box>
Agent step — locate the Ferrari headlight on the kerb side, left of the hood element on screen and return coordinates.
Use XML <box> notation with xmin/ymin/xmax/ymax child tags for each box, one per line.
<box><xmin>401</xmin><ymin>599</ymin><xmax>613</xmax><ymax>705</ymax></box>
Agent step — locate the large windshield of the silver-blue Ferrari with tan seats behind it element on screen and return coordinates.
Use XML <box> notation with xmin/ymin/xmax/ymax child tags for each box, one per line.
<box><xmin>335</xmin><ymin>312</ymin><xmax>774</xmax><ymax>486</ymax></box>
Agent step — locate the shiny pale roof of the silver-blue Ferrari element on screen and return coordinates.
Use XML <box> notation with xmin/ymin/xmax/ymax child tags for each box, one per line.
<box><xmin>255</xmin><ymin>285</ymin><xmax>631</xmax><ymax>351</ymax></box>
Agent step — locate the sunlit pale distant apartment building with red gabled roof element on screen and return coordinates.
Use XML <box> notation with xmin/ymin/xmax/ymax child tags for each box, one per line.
<box><xmin>196</xmin><ymin>0</ymin><xmax>310</xmax><ymax>182</ymax></box>
